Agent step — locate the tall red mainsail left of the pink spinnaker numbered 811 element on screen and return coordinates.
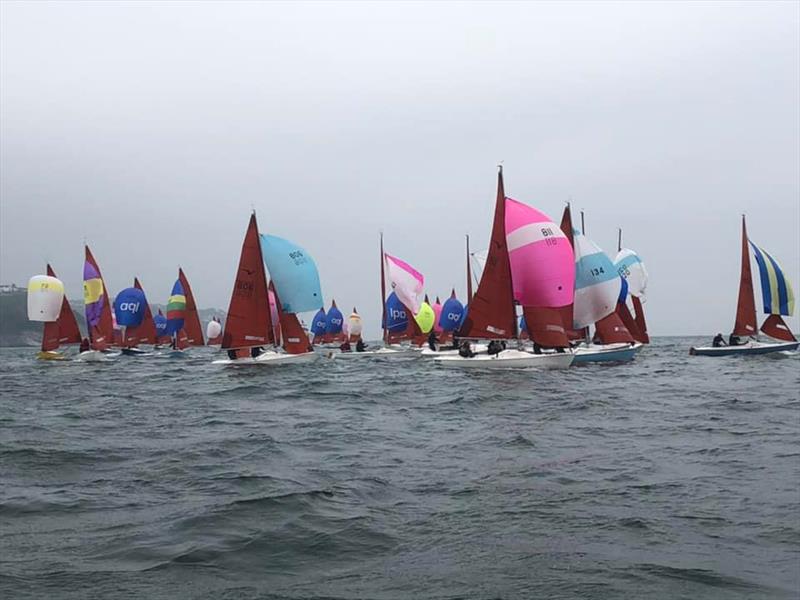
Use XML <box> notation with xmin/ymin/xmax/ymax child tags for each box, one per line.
<box><xmin>459</xmin><ymin>167</ymin><xmax>517</xmax><ymax>339</ymax></box>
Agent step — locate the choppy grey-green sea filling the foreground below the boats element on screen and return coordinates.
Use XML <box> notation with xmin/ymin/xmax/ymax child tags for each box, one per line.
<box><xmin>0</xmin><ymin>339</ymin><xmax>800</xmax><ymax>600</ymax></box>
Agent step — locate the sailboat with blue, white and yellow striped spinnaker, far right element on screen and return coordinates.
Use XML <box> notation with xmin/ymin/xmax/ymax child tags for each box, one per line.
<box><xmin>689</xmin><ymin>215</ymin><xmax>798</xmax><ymax>356</ymax></box>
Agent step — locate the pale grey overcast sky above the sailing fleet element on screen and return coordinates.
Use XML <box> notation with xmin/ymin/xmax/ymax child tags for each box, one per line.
<box><xmin>0</xmin><ymin>2</ymin><xmax>800</xmax><ymax>337</ymax></box>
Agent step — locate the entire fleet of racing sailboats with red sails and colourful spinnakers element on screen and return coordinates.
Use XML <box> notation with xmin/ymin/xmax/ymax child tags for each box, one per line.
<box><xmin>21</xmin><ymin>167</ymin><xmax>798</xmax><ymax>369</ymax></box>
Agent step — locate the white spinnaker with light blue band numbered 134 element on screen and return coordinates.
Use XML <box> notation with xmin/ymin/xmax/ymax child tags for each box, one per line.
<box><xmin>572</xmin><ymin>235</ymin><xmax>622</xmax><ymax>329</ymax></box>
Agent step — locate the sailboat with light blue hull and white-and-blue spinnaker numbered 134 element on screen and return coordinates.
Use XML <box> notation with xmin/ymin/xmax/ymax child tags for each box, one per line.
<box><xmin>561</xmin><ymin>204</ymin><xmax>641</xmax><ymax>364</ymax></box>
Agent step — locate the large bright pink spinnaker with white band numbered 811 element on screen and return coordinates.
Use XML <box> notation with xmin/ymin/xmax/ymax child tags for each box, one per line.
<box><xmin>505</xmin><ymin>198</ymin><xmax>575</xmax><ymax>308</ymax></box>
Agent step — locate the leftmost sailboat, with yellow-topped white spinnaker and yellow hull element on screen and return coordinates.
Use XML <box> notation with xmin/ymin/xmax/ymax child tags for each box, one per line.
<box><xmin>28</xmin><ymin>264</ymin><xmax>81</xmax><ymax>360</ymax></box>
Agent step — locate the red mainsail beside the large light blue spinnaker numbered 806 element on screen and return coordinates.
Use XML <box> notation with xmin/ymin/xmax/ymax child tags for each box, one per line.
<box><xmin>222</xmin><ymin>213</ymin><xmax>274</xmax><ymax>350</ymax></box>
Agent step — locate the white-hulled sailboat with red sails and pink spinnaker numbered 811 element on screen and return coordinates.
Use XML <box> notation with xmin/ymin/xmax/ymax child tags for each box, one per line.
<box><xmin>434</xmin><ymin>167</ymin><xmax>574</xmax><ymax>368</ymax></box>
